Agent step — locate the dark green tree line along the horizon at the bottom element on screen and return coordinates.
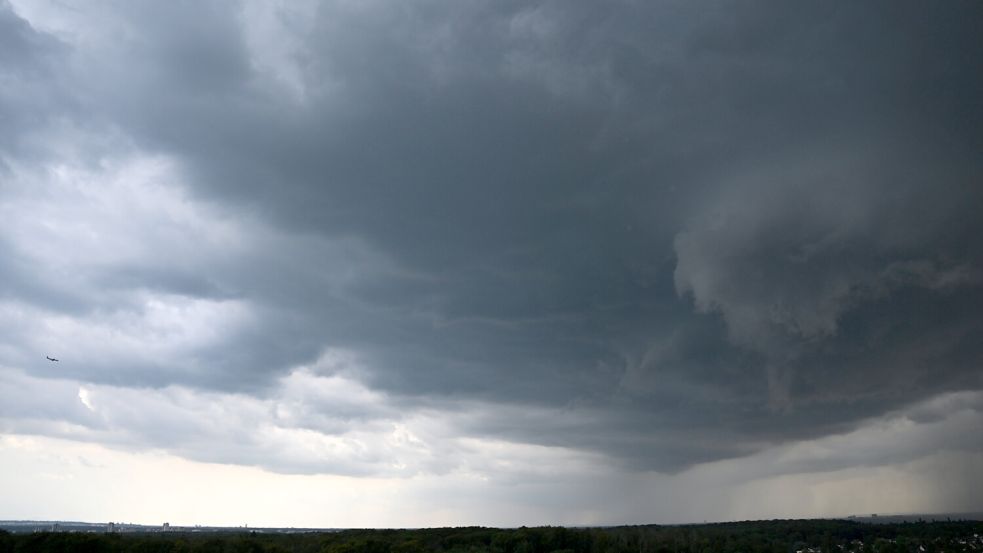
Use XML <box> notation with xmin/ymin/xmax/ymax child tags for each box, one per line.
<box><xmin>0</xmin><ymin>520</ymin><xmax>983</xmax><ymax>553</ymax></box>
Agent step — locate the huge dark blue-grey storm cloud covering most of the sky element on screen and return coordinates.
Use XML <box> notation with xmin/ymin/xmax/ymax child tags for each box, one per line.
<box><xmin>2</xmin><ymin>2</ymin><xmax>983</xmax><ymax>470</ymax></box>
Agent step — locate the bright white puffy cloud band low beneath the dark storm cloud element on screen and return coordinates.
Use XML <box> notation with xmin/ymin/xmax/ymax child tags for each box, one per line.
<box><xmin>0</xmin><ymin>358</ymin><xmax>616</xmax><ymax>483</ymax></box>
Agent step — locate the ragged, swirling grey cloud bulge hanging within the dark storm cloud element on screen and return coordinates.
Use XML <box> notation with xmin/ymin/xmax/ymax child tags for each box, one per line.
<box><xmin>675</xmin><ymin>144</ymin><xmax>983</xmax><ymax>350</ymax></box>
